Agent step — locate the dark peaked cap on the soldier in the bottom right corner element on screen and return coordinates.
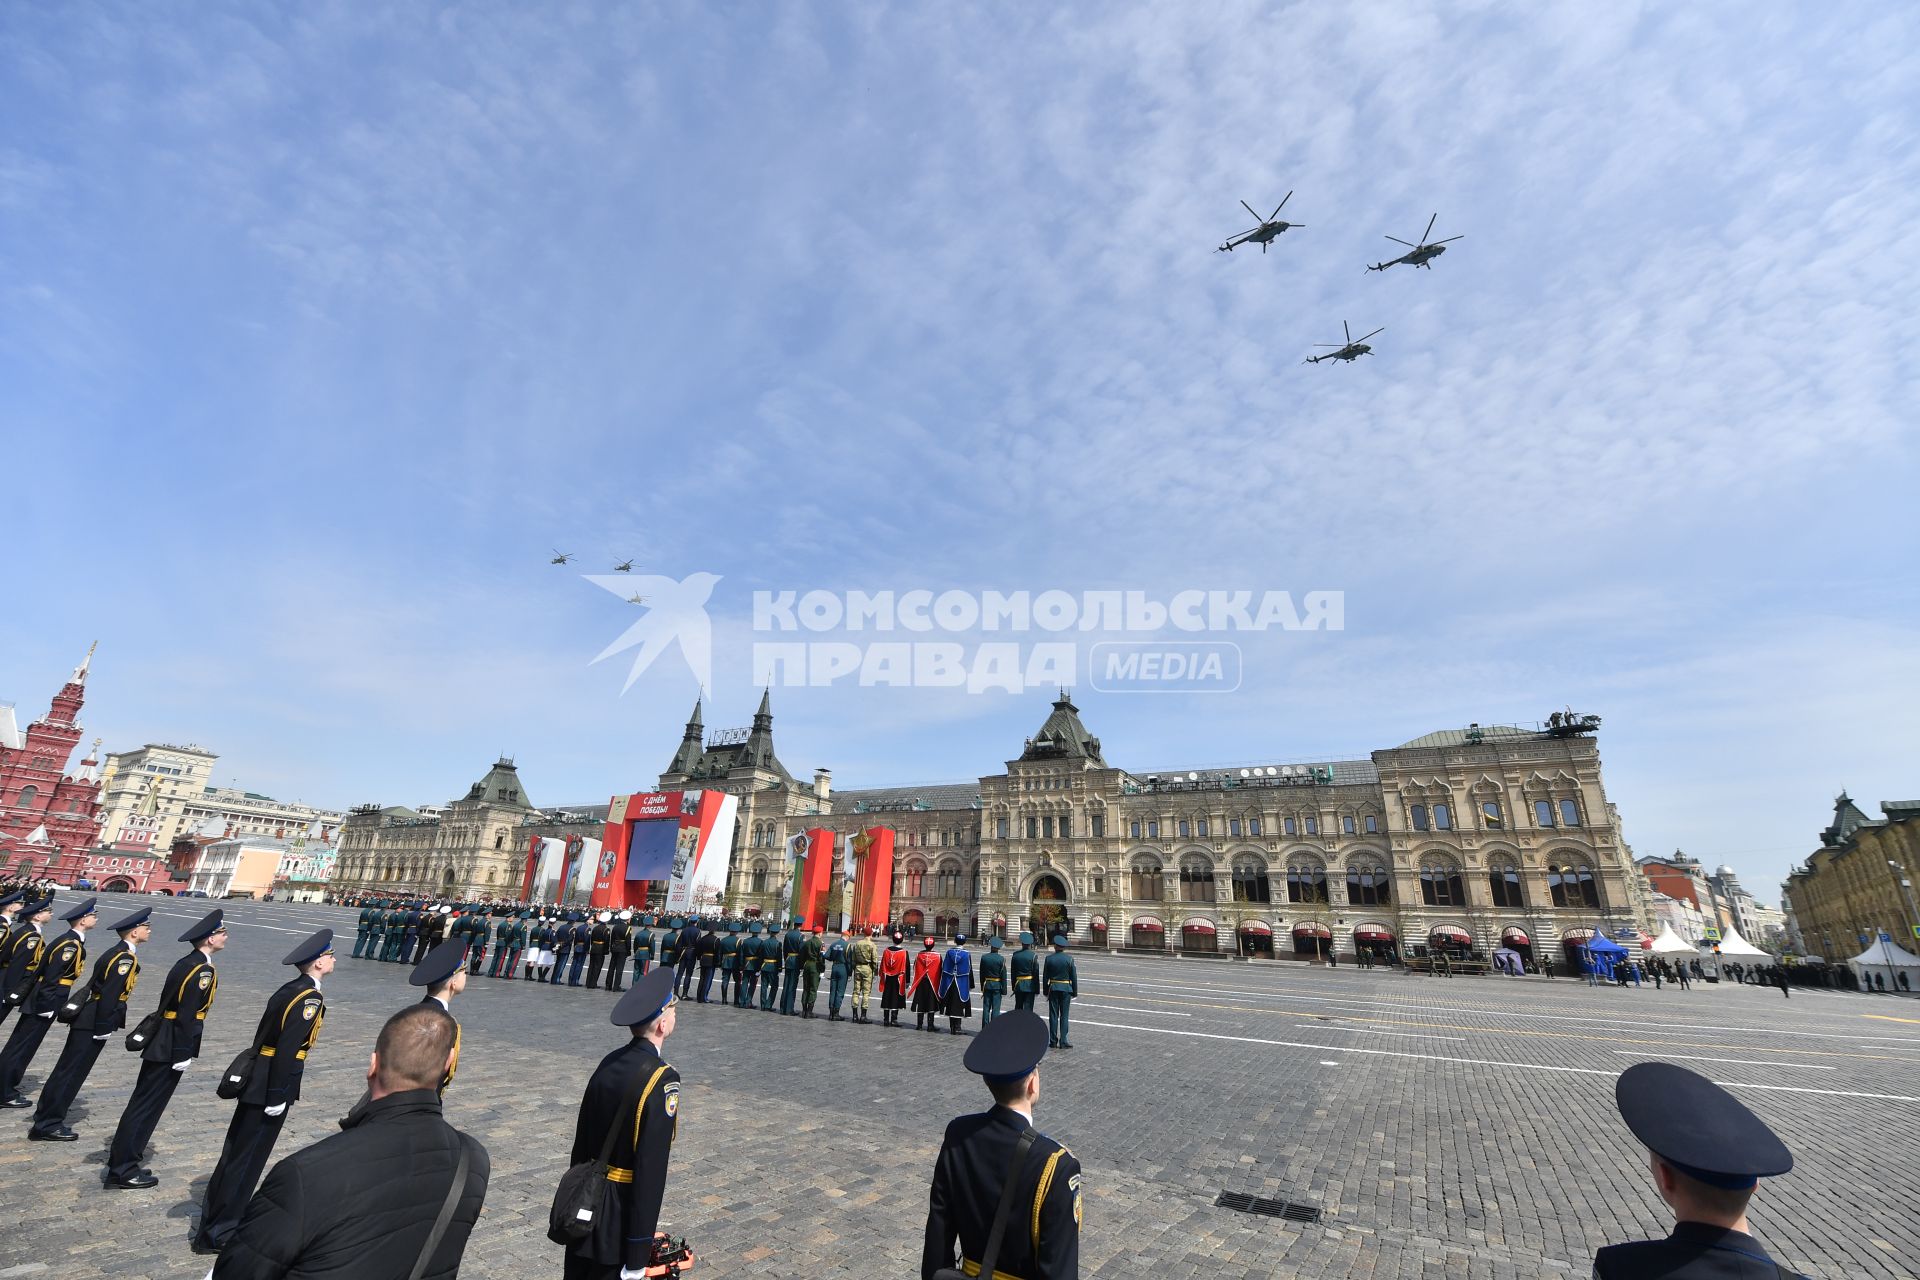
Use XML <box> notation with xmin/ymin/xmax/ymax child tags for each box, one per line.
<box><xmin>1613</xmin><ymin>1063</ymin><xmax>1793</xmax><ymax>1190</ymax></box>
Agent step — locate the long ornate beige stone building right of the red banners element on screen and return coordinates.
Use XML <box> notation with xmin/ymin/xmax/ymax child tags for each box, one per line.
<box><xmin>725</xmin><ymin>695</ymin><xmax>1649</xmax><ymax>956</ymax></box>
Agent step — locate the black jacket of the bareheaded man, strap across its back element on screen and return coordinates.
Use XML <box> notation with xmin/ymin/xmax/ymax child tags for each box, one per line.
<box><xmin>213</xmin><ymin>1088</ymin><xmax>488</xmax><ymax>1280</ymax></box>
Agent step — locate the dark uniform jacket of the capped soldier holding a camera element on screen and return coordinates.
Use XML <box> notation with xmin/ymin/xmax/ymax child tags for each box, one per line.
<box><xmin>570</xmin><ymin>1036</ymin><xmax>680</xmax><ymax>1270</ymax></box>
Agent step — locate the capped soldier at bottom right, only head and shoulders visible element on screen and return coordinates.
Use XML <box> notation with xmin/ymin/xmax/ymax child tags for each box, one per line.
<box><xmin>1594</xmin><ymin>1063</ymin><xmax>1795</xmax><ymax>1280</ymax></box>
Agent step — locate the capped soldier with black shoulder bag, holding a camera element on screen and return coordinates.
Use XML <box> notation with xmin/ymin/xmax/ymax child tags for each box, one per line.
<box><xmin>564</xmin><ymin>965</ymin><xmax>680</xmax><ymax>1280</ymax></box>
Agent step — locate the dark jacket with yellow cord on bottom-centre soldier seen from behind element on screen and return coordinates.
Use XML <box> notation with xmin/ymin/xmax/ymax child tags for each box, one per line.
<box><xmin>920</xmin><ymin>1107</ymin><xmax>1081</xmax><ymax>1280</ymax></box>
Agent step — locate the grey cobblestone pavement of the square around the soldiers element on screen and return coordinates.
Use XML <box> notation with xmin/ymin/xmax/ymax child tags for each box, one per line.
<box><xmin>0</xmin><ymin>898</ymin><xmax>1920</xmax><ymax>1280</ymax></box>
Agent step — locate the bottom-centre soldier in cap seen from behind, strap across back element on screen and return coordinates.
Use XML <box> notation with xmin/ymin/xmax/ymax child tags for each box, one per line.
<box><xmin>920</xmin><ymin>1009</ymin><xmax>1081</xmax><ymax>1280</ymax></box>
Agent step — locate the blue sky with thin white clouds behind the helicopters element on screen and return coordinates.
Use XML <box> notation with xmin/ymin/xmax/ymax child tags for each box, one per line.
<box><xmin>0</xmin><ymin>0</ymin><xmax>1920</xmax><ymax>900</ymax></box>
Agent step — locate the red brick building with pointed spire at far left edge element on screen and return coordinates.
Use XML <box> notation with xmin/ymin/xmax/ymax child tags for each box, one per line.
<box><xmin>0</xmin><ymin>649</ymin><xmax>100</xmax><ymax>885</ymax></box>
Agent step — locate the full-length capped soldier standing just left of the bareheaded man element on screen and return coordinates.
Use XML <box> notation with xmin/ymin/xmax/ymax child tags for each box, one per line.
<box><xmin>194</xmin><ymin>929</ymin><xmax>334</xmax><ymax>1253</ymax></box>
